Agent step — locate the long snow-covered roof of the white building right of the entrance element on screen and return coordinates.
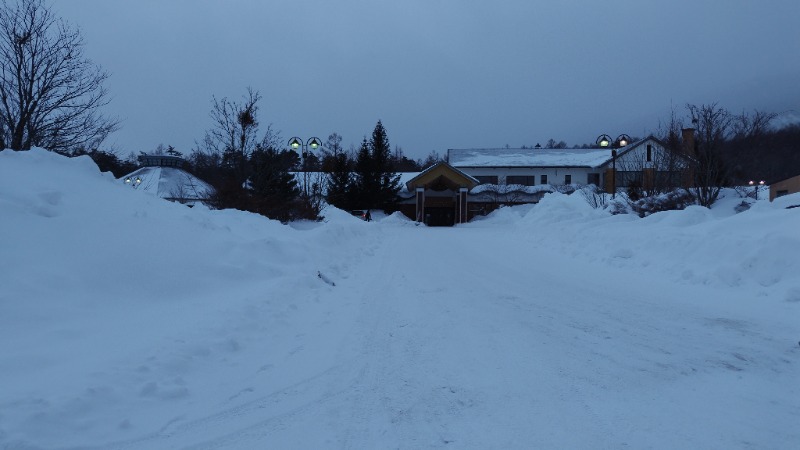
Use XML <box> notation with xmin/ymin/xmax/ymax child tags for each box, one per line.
<box><xmin>447</xmin><ymin>136</ymin><xmax>659</xmax><ymax>168</ymax></box>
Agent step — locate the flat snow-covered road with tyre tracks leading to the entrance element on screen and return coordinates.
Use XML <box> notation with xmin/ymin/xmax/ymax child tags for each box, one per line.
<box><xmin>109</xmin><ymin>226</ymin><xmax>800</xmax><ymax>449</ymax></box>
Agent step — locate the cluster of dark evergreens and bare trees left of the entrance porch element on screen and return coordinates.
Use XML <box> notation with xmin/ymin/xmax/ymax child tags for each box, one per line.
<box><xmin>182</xmin><ymin>89</ymin><xmax>403</xmax><ymax>221</ymax></box>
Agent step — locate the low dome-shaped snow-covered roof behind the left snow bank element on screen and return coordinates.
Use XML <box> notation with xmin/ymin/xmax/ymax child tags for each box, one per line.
<box><xmin>120</xmin><ymin>166</ymin><xmax>214</xmax><ymax>201</ymax></box>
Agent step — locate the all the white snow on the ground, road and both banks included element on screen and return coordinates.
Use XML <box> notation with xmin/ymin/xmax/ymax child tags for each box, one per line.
<box><xmin>0</xmin><ymin>149</ymin><xmax>800</xmax><ymax>449</ymax></box>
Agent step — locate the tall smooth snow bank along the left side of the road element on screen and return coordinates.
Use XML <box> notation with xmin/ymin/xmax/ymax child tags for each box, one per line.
<box><xmin>0</xmin><ymin>149</ymin><xmax>353</xmax><ymax>446</ymax></box>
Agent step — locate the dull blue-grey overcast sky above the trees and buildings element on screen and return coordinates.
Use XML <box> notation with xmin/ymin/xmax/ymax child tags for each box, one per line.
<box><xmin>52</xmin><ymin>0</ymin><xmax>800</xmax><ymax>158</ymax></box>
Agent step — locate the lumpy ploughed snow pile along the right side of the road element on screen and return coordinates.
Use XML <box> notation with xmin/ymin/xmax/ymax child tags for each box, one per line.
<box><xmin>520</xmin><ymin>188</ymin><xmax>800</xmax><ymax>296</ymax></box>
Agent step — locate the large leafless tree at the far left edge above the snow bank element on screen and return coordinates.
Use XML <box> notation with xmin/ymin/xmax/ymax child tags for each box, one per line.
<box><xmin>0</xmin><ymin>0</ymin><xmax>118</xmax><ymax>152</ymax></box>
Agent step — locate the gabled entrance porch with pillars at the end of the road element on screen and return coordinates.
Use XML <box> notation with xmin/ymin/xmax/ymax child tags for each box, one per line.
<box><xmin>403</xmin><ymin>162</ymin><xmax>480</xmax><ymax>226</ymax></box>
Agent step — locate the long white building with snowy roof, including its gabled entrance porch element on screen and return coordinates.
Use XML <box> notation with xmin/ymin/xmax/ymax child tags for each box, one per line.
<box><xmin>400</xmin><ymin>136</ymin><xmax>689</xmax><ymax>226</ymax></box>
